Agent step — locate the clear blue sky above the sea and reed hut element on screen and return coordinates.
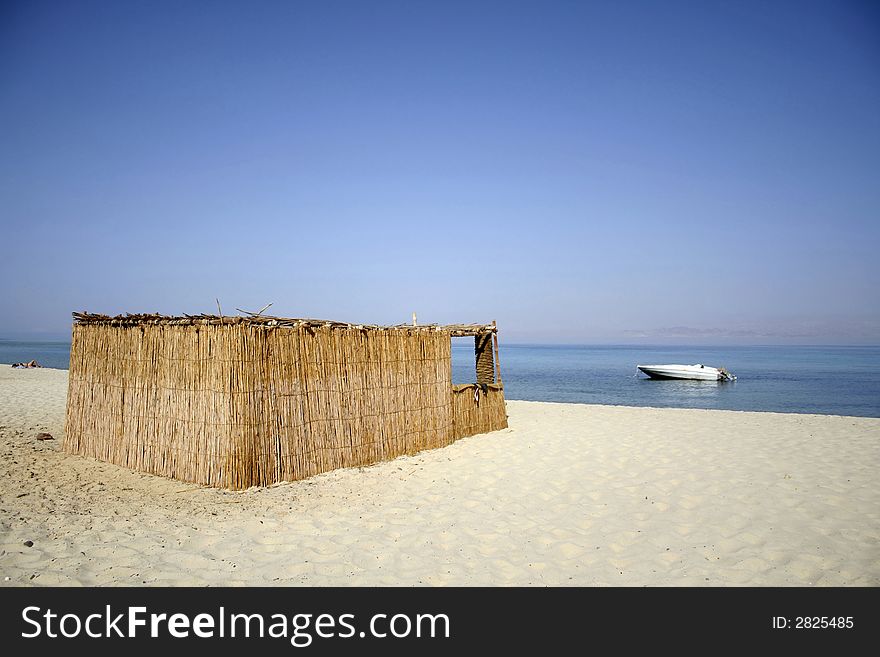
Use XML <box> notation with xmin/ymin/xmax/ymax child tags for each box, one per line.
<box><xmin>0</xmin><ymin>0</ymin><xmax>880</xmax><ymax>344</ymax></box>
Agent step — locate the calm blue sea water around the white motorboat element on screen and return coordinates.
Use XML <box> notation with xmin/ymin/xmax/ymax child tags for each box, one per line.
<box><xmin>0</xmin><ymin>339</ymin><xmax>880</xmax><ymax>417</ymax></box>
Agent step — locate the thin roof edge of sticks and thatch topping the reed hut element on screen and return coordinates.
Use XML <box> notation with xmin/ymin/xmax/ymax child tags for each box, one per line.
<box><xmin>73</xmin><ymin>312</ymin><xmax>497</xmax><ymax>337</ymax></box>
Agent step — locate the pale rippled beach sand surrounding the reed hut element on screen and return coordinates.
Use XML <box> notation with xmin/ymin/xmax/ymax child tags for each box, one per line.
<box><xmin>0</xmin><ymin>366</ymin><xmax>880</xmax><ymax>586</ymax></box>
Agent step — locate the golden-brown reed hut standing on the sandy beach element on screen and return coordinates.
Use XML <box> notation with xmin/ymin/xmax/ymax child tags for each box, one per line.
<box><xmin>63</xmin><ymin>313</ymin><xmax>507</xmax><ymax>489</ymax></box>
